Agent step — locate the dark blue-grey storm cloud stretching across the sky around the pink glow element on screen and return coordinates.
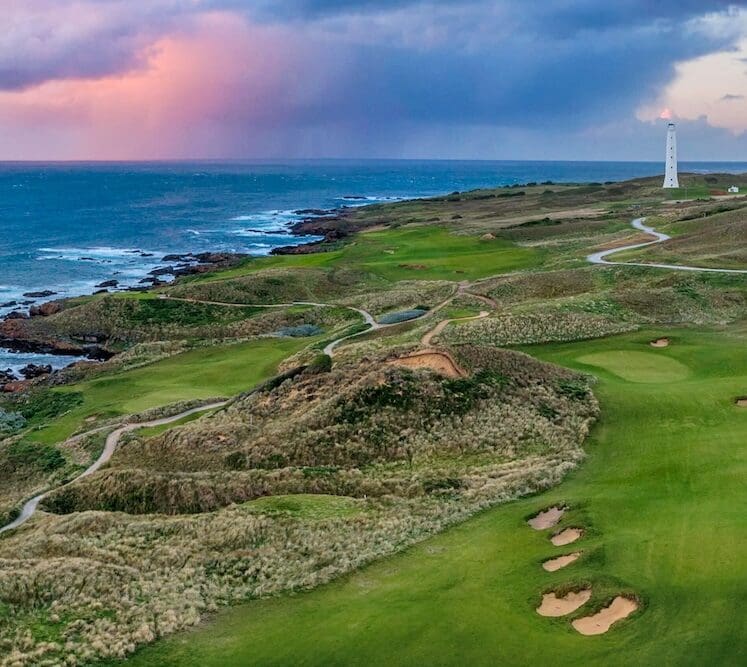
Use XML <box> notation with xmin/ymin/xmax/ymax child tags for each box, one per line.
<box><xmin>0</xmin><ymin>0</ymin><xmax>747</xmax><ymax>155</ymax></box>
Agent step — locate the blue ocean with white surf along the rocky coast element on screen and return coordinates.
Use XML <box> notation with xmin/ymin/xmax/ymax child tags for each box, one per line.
<box><xmin>0</xmin><ymin>160</ymin><xmax>747</xmax><ymax>370</ymax></box>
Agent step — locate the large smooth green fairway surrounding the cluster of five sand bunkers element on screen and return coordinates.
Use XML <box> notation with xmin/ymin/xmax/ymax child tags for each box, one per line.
<box><xmin>122</xmin><ymin>329</ymin><xmax>747</xmax><ymax>667</ymax></box>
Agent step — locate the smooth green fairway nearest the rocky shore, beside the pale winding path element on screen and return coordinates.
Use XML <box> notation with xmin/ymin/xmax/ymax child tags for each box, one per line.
<box><xmin>29</xmin><ymin>338</ymin><xmax>314</xmax><ymax>443</ymax></box>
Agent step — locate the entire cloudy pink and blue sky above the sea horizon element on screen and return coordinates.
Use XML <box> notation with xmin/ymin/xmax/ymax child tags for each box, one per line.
<box><xmin>0</xmin><ymin>0</ymin><xmax>747</xmax><ymax>161</ymax></box>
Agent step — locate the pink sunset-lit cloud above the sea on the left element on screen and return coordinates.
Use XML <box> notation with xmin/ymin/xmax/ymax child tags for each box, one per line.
<box><xmin>0</xmin><ymin>13</ymin><xmax>334</xmax><ymax>159</ymax></box>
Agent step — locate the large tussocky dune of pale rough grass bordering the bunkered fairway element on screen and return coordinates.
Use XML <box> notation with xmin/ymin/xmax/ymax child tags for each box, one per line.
<box><xmin>0</xmin><ymin>347</ymin><xmax>597</xmax><ymax>665</ymax></box>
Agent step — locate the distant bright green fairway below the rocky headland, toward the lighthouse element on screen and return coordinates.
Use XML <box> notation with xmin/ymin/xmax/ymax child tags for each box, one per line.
<box><xmin>186</xmin><ymin>226</ymin><xmax>543</xmax><ymax>281</ymax></box>
